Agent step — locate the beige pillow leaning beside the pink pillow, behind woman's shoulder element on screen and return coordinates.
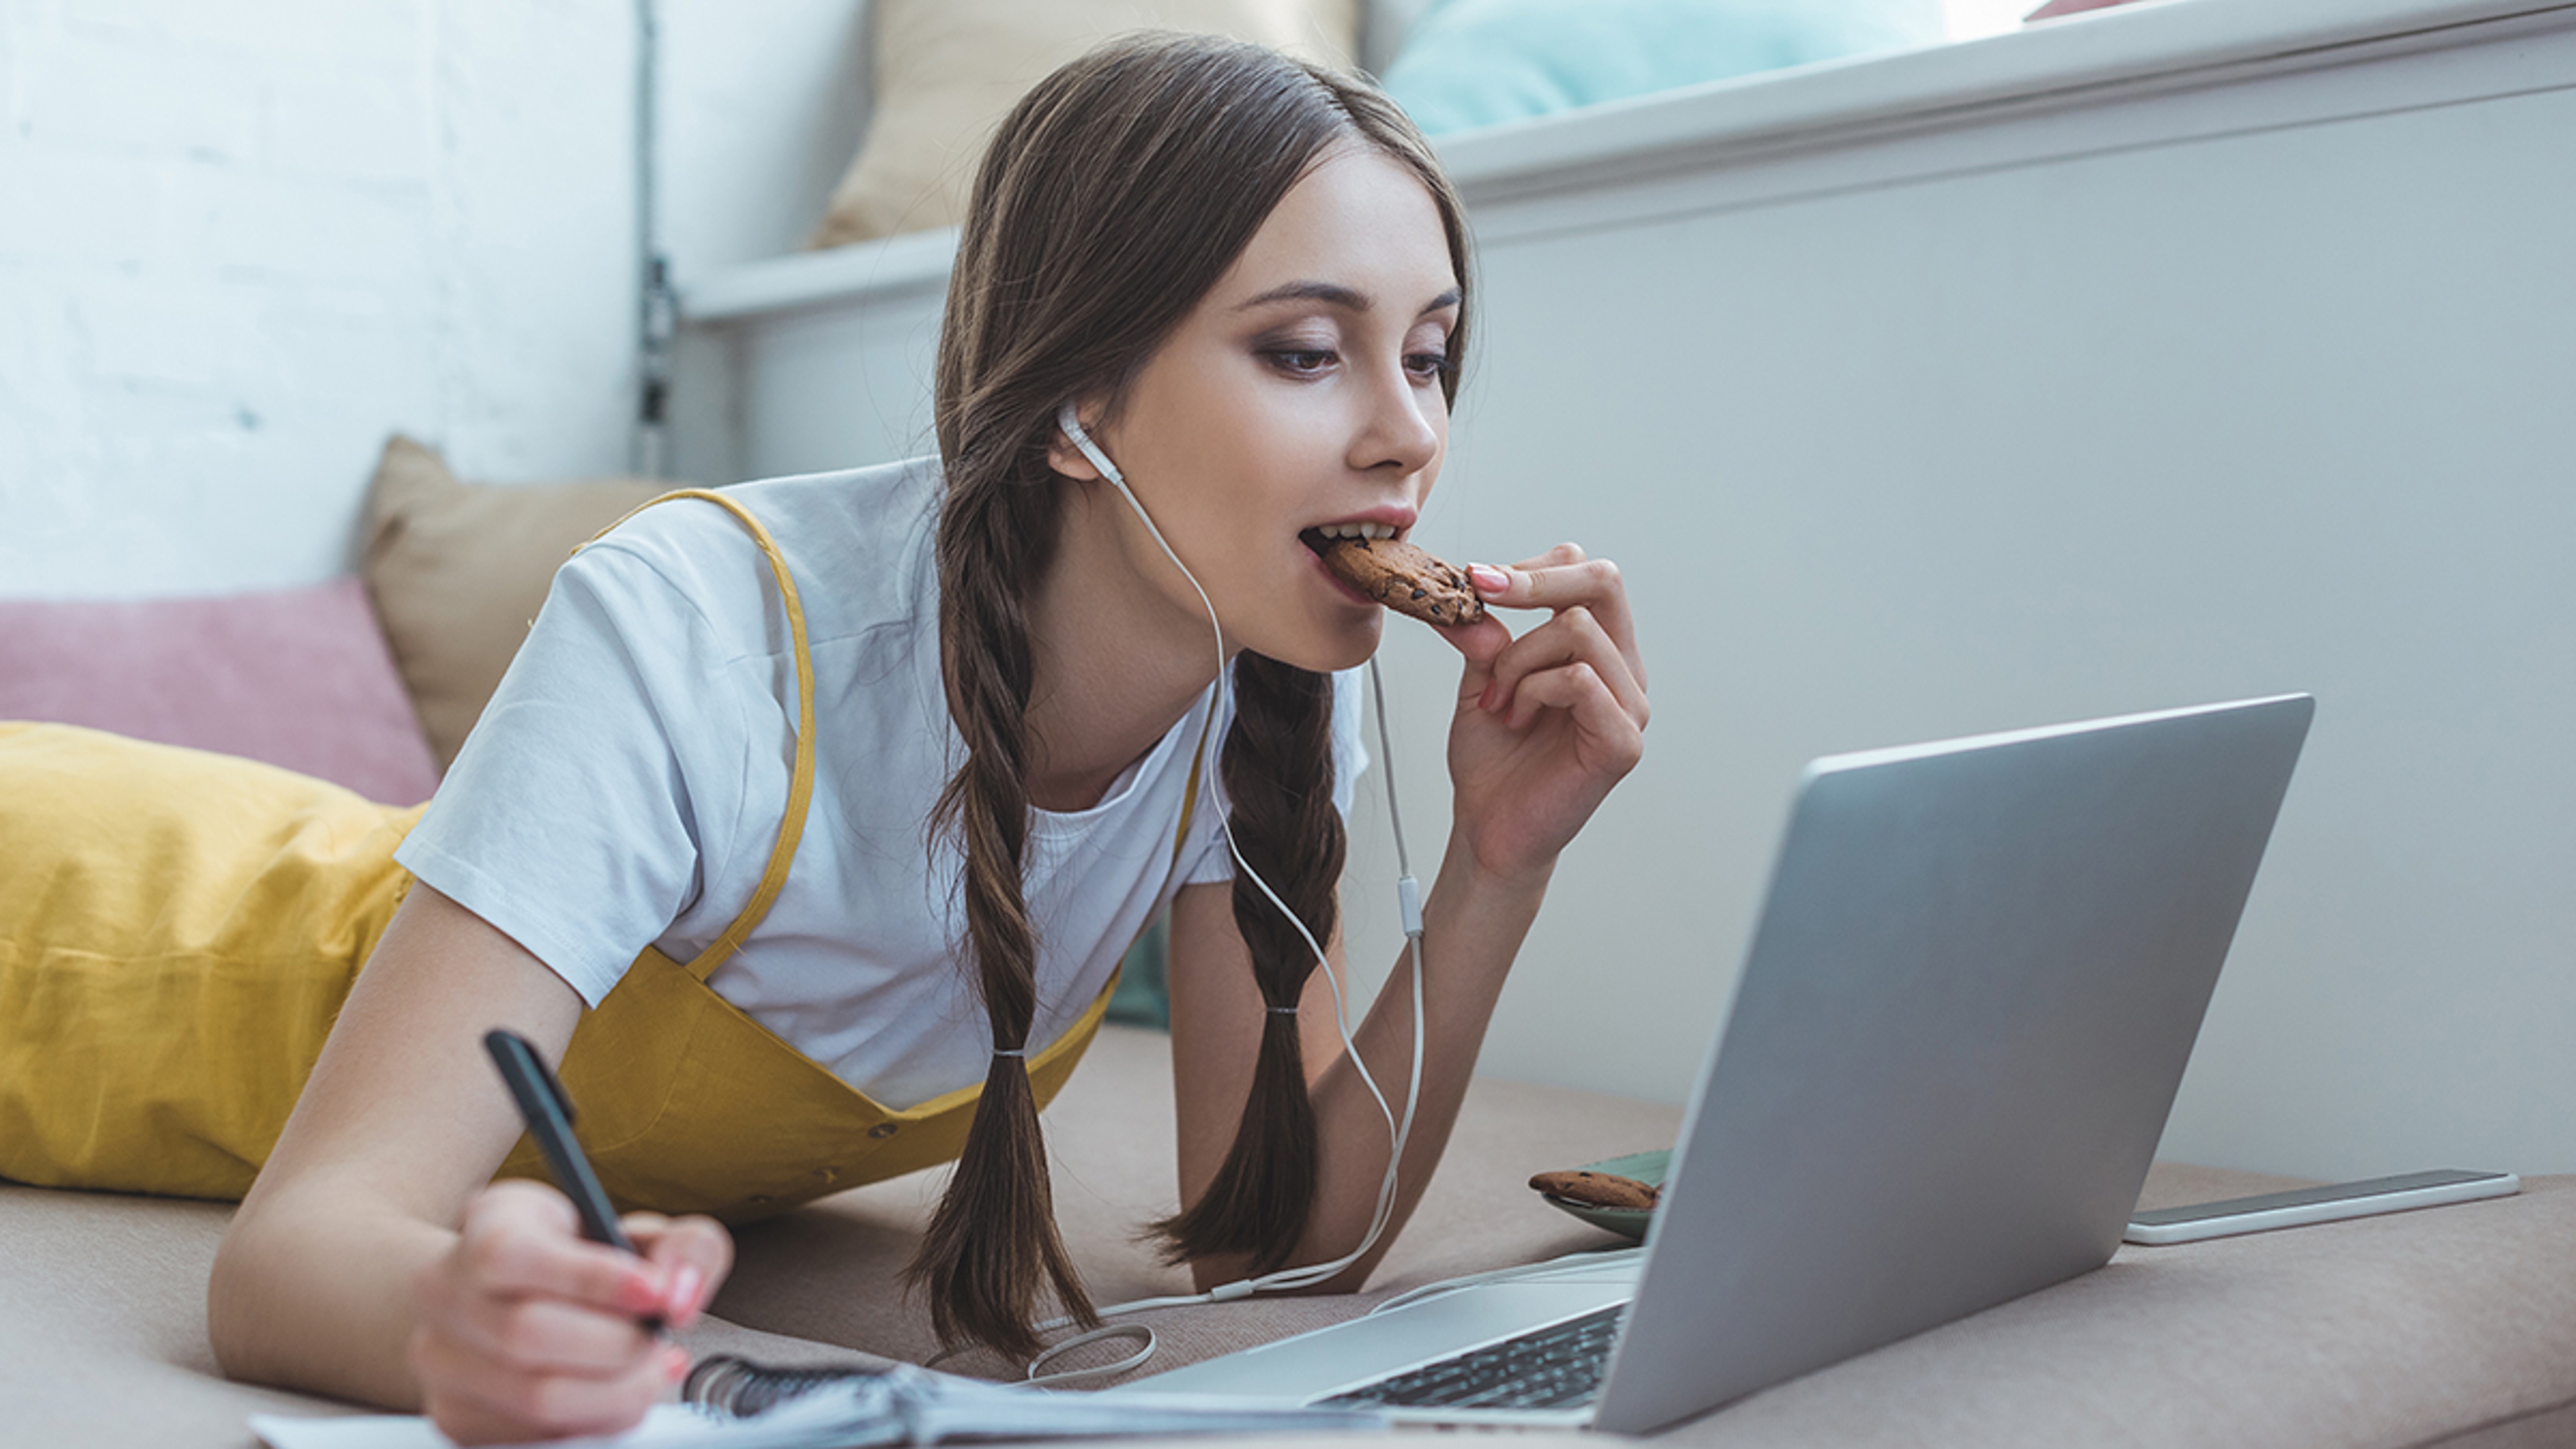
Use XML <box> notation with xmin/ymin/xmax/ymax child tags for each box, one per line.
<box><xmin>363</xmin><ymin>436</ymin><xmax>685</xmax><ymax>771</ymax></box>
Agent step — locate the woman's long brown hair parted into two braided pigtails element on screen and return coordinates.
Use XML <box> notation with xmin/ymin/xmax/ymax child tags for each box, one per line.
<box><xmin>910</xmin><ymin>34</ymin><xmax>1468</xmax><ymax>1356</ymax></box>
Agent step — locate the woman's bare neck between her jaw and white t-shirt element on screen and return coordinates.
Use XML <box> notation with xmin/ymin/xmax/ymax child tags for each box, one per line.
<box><xmin>1028</xmin><ymin>480</ymin><xmax>1232</xmax><ymax>812</ymax></box>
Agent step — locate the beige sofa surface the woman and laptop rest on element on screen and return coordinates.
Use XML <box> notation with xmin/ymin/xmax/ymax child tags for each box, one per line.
<box><xmin>0</xmin><ymin>1026</ymin><xmax>2576</xmax><ymax>1449</ymax></box>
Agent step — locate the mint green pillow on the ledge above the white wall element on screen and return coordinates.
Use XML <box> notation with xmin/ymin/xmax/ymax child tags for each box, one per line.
<box><xmin>1386</xmin><ymin>0</ymin><xmax>1942</xmax><ymax>137</ymax></box>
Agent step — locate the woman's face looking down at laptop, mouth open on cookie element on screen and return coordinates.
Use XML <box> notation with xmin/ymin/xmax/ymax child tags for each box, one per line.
<box><xmin>1054</xmin><ymin>147</ymin><xmax>1458</xmax><ymax>670</ymax></box>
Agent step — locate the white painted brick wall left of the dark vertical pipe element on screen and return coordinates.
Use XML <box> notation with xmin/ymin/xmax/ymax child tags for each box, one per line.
<box><xmin>0</xmin><ymin>0</ymin><xmax>644</xmax><ymax>598</ymax></box>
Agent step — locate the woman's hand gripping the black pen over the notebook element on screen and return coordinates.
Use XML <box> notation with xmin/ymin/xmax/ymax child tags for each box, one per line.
<box><xmin>410</xmin><ymin>1181</ymin><xmax>734</xmax><ymax>1444</ymax></box>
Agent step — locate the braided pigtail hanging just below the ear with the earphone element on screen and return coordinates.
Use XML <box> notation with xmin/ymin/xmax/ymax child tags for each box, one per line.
<box><xmin>904</xmin><ymin>472</ymin><xmax>1097</xmax><ymax>1358</ymax></box>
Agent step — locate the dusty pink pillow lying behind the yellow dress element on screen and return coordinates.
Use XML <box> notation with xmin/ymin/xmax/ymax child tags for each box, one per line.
<box><xmin>0</xmin><ymin>578</ymin><xmax>438</xmax><ymax>804</ymax></box>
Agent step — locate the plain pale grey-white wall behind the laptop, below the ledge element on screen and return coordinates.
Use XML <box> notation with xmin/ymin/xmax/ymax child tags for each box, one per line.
<box><xmin>1352</xmin><ymin>5</ymin><xmax>2576</xmax><ymax>1178</ymax></box>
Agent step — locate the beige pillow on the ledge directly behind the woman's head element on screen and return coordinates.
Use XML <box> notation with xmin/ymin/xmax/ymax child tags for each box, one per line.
<box><xmin>806</xmin><ymin>0</ymin><xmax>1360</xmax><ymax>248</ymax></box>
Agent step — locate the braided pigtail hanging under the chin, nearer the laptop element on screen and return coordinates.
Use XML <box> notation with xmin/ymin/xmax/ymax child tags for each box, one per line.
<box><xmin>1154</xmin><ymin>652</ymin><xmax>1344</xmax><ymax>1274</ymax></box>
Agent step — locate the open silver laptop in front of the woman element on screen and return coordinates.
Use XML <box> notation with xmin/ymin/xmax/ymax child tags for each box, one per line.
<box><xmin>1108</xmin><ymin>694</ymin><xmax>2316</xmax><ymax>1434</ymax></box>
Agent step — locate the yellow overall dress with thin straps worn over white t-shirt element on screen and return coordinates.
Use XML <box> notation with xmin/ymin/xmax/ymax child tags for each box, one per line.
<box><xmin>0</xmin><ymin>490</ymin><xmax>1138</xmax><ymax>1222</ymax></box>
